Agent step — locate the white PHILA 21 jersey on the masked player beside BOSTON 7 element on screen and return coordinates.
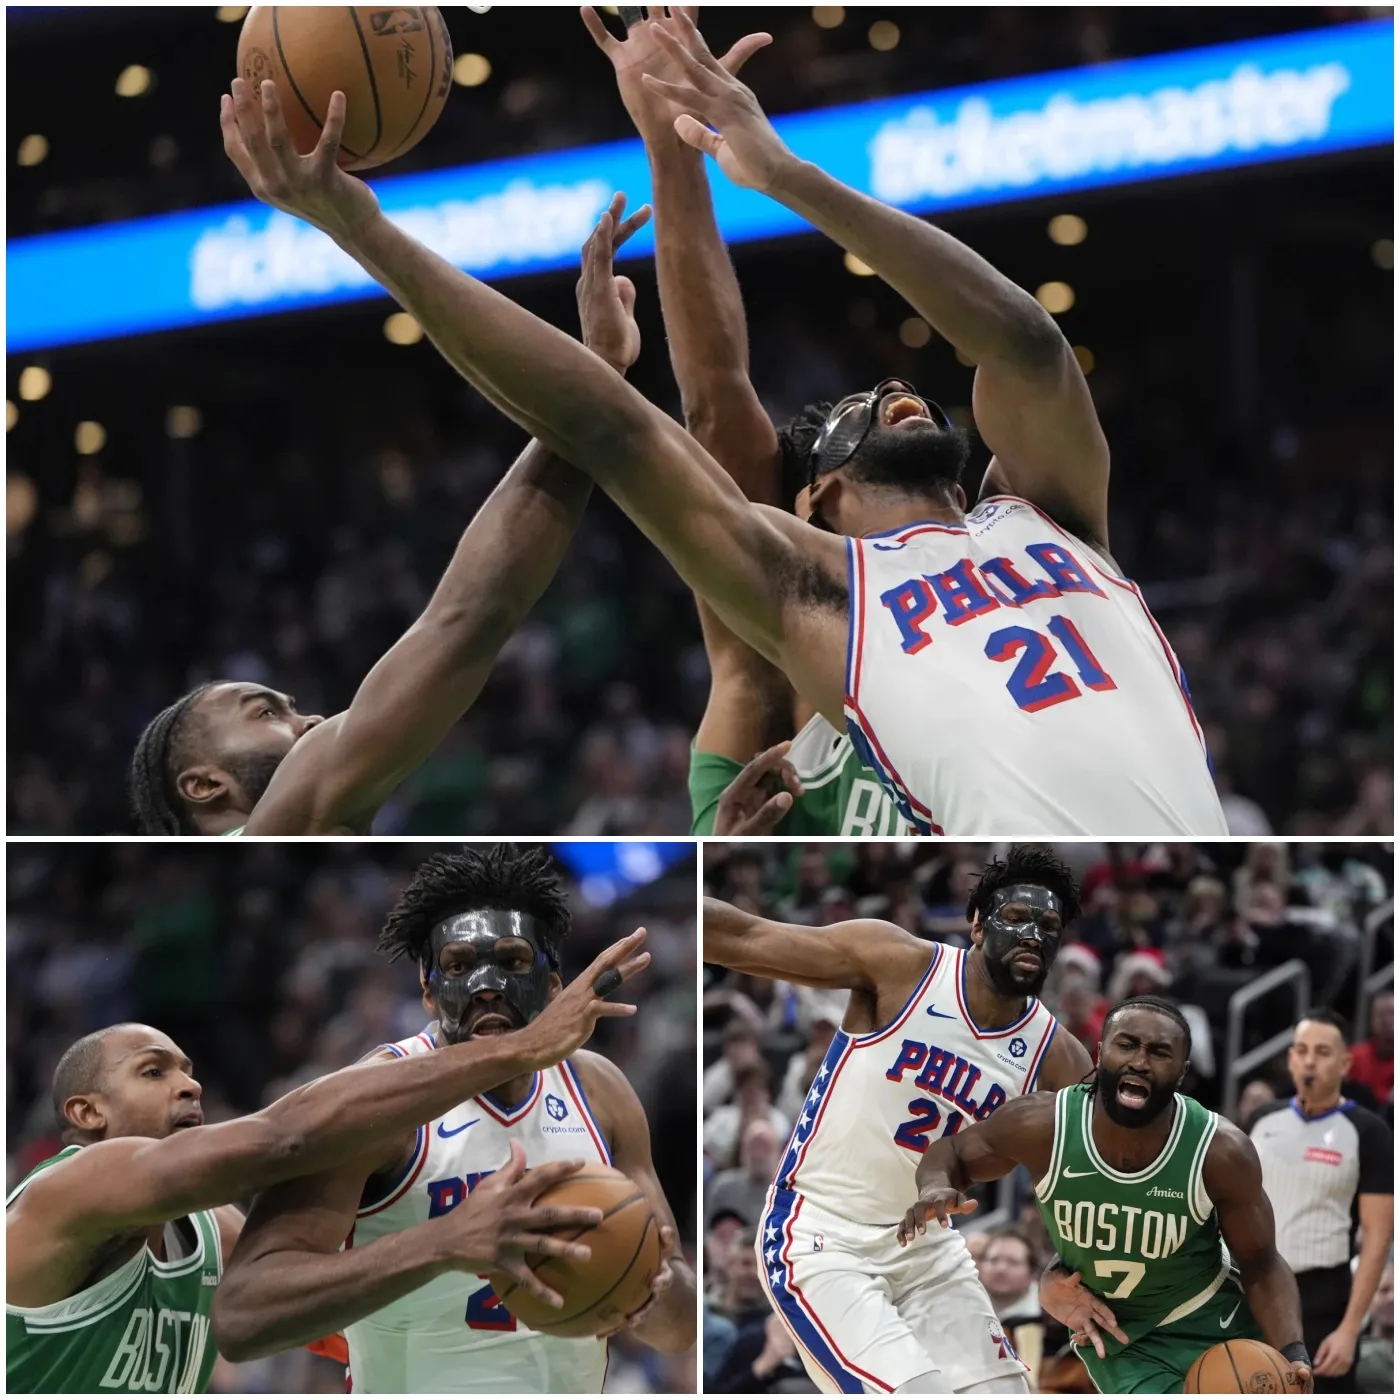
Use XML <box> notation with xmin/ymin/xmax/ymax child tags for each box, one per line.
<box><xmin>769</xmin><ymin>944</ymin><xmax>1058</xmax><ymax>1238</ymax></box>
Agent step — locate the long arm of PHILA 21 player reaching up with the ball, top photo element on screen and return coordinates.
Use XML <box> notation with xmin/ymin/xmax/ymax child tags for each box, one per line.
<box><xmin>223</xmin><ymin>78</ymin><xmax>846</xmax><ymax>718</ymax></box>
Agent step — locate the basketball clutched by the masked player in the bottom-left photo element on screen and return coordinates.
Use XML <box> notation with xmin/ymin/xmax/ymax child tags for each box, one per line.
<box><xmin>487</xmin><ymin>1166</ymin><xmax>661</xmax><ymax>1337</ymax></box>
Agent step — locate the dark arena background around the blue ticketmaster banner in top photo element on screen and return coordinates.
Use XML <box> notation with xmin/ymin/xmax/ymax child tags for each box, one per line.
<box><xmin>7</xmin><ymin>7</ymin><xmax>1394</xmax><ymax>836</ymax></box>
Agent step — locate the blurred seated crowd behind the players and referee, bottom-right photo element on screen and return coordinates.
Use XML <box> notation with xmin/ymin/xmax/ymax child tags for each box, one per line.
<box><xmin>701</xmin><ymin>841</ymin><xmax>1394</xmax><ymax>1393</ymax></box>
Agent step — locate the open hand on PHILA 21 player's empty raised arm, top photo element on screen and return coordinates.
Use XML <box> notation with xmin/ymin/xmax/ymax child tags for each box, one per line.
<box><xmin>638</xmin><ymin>10</ymin><xmax>798</xmax><ymax>190</ymax></box>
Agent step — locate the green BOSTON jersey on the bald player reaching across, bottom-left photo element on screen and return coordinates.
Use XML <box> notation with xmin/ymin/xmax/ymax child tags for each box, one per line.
<box><xmin>4</xmin><ymin>1147</ymin><xmax>224</xmax><ymax>1394</ymax></box>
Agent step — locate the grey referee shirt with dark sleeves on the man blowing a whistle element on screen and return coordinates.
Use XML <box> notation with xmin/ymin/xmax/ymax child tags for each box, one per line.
<box><xmin>1246</xmin><ymin>1099</ymin><xmax>1394</xmax><ymax>1274</ymax></box>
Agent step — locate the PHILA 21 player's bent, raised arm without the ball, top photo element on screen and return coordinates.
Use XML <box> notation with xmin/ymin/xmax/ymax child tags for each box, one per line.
<box><xmin>647</xmin><ymin>10</ymin><xmax>1109</xmax><ymax>547</ymax></box>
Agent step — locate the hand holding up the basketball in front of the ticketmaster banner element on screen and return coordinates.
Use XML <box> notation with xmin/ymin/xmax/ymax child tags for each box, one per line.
<box><xmin>218</xmin><ymin>78</ymin><xmax>379</xmax><ymax>239</ymax></box>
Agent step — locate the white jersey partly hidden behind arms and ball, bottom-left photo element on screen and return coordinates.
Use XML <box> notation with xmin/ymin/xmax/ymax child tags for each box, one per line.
<box><xmin>346</xmin><ymin>1032</ymin><xmax>612</xmax><ymax>1394</ymax></box>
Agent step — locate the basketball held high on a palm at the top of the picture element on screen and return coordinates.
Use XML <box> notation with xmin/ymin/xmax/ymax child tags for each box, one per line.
<box><xmin>238</xmin><ymin>6</ymin><xmax>452</xmax><ymax>171</ymax></box>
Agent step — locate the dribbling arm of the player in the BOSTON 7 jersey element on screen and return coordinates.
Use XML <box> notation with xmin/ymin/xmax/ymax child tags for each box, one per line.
<box><xmin>1201</xmin><ymin>1119</ymin><xmax>1312</xmax><ymax>1390</ymax></box>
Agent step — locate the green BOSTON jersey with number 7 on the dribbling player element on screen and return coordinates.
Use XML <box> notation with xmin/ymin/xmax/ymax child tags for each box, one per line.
<box><xmin>1036</xmin><ymin>1084</ymin><xmax>1231</xmax><ymax>1357</ymax></box>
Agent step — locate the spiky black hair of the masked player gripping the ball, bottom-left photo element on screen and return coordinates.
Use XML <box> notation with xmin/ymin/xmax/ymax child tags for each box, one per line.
<box><xmin>377</xmin><ymin>841</ymin><xmax>571</xmax><ymax>972</ymax></box>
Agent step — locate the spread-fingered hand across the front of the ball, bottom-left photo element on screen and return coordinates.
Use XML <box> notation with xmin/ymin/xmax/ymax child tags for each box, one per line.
<box><xmin>438</xmin><ymin>1141</ymin><xmax>603</xmax><ymax>1308</ymax></box>
